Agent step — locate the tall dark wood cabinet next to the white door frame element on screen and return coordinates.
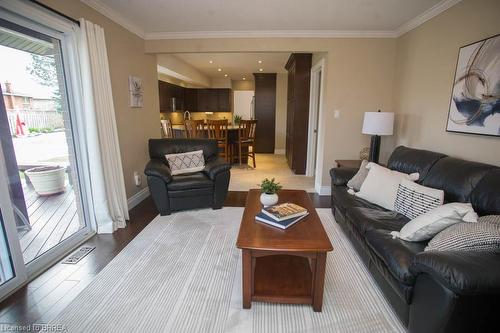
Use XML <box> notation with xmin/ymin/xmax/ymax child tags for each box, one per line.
<box><xmin>285</xmin><ymin>53</ymin><xmax>312</xmax><ymax>175</ymax></box>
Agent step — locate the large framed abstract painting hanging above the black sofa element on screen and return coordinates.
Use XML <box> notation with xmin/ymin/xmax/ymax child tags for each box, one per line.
<box><xmin>446</xmin><ymin>34</ymin><xmax>500</xmax><ymax>136</ymax></box>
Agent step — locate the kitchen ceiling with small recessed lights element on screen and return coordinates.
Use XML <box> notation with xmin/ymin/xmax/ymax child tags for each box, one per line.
<box><xmin>175</xmin><ymin>53</ymin><xmax>290</xmax><ymax>80</ymax></box>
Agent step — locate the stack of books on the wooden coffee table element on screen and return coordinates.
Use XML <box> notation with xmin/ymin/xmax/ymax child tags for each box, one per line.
<box><xmin>255</xmin><ymin>202</ymin><xmax>309</xmax><ymax>229</ymax></box>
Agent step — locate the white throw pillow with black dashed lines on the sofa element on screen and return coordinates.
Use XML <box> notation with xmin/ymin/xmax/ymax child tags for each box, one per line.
<box><xmin>394</xmin><ymin>180</ymin><xmax>444</xmax><ymax>220</ymax></box>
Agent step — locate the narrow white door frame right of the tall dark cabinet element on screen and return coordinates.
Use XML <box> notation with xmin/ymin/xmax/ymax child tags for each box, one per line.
<box><xmin>306</xmin><ymin>58</ymin><xmax>325</xmax><ymax>182</ymax></box>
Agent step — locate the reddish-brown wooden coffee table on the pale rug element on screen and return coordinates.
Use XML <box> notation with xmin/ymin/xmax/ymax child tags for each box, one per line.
<box><xmin>236</xmin><ymin>190</ymin><xmax>333</xmax><ymax>312</ymax></box>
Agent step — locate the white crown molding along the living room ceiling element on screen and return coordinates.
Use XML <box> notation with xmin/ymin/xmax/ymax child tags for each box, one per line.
<box><xmin>80</xmin><ymin>0</ymin><xmax>462</xmax><ymax>40</ymax></box>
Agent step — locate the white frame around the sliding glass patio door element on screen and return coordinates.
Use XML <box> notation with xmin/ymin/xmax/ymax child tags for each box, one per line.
<box><xmin>0</xmin><ymin>0</ymin><xmax>96</xmax><ymax>282</ymax></box>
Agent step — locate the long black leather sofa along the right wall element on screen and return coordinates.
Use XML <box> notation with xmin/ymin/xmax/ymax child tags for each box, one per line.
<box><xmin>330</xmin><ymin>146</ymin><xmax>500</xmax><ymax>333</ymax></box>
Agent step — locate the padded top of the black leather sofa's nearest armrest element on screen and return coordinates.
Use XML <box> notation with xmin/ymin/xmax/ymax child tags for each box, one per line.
<box><xmin>410</xmin><ymin>251</ymin><xmax>500</xmax><ymax>295</ymax></box>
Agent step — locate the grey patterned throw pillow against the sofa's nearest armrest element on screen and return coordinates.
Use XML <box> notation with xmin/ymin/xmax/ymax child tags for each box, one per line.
<box><xmin>425</xmin><ymin>215</ymin><xmax>500</xmax><ymax>252</ymax></box>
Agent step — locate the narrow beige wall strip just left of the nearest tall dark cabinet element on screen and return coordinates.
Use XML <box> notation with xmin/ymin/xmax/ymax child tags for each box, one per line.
<box><xmin>274</xmin><ymin>73</ymin><xmax>288</xmax><ymax>153</ymax></box>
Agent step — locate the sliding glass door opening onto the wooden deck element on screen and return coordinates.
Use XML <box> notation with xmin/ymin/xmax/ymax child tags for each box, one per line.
<box><xmin>0</xmin><ymin>1</ymin><xmax>92</xmax><ymax>297</ymax></box>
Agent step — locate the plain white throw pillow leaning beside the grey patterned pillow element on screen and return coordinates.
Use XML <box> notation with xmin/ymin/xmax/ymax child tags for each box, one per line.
<box><xmin>391</xmin><ymin>202</ymin><xmax>478</xmax><ymax>242</ymax></box>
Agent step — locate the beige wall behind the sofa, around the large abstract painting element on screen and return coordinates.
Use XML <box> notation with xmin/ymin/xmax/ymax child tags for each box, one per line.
<box><xmin>392</xmin><ymin>0</ymin><xmax>500</xmax><ymax>165</ymax></box>
